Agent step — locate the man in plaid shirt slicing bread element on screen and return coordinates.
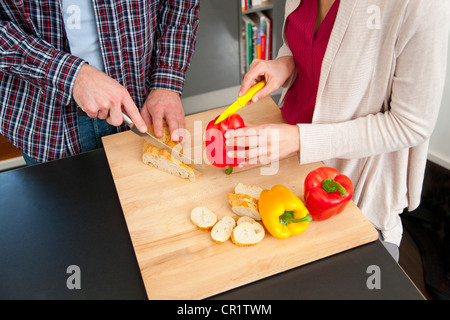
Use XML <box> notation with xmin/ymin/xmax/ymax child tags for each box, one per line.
<box><xmin>0</xmin><ymin>0</ymin><xmax>200</xmax><ymax>164</ymax></box>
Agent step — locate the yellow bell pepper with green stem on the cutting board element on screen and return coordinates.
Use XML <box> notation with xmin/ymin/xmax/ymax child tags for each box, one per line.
<box><xmin>258</xmin><ymin>185</ymin><xmax>312</xmax><ymax>239</ymax></box>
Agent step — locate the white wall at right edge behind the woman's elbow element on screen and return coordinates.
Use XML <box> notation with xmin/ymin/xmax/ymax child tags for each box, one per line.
<box><xmin>428</xmin><ymin>34</ymin><xmax>450</xmax><ymax>170</ymax></box>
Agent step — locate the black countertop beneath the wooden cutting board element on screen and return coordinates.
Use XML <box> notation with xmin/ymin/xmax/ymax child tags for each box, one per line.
<box><xmin>0</xmin><ymin>149</ymin><xmax>423</xmax><ymax>300</ymax></box>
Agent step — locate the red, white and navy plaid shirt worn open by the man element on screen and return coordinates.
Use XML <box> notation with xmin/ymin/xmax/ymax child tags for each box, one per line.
<box><xmin>0</xmin><ymin>0</ymin><xmax>200</xmax><ymax>162</ymax></box>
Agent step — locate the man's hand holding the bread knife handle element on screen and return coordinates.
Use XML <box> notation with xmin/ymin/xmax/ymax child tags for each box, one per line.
<box><xmin>73</xmin><ymin>63</ymin><xmax>147</xmax><ymax>132</ymax></box>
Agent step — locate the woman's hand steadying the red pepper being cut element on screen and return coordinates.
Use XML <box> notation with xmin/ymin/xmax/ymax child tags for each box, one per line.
<box><xmin>225</xmin><ymin>124</ymin><xmax>300</xmax><ymax>167</ymax></box>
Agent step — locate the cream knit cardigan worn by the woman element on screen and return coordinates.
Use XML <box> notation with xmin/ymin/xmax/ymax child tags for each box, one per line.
<box><xmin>278</xmin><ymin>0</ymin><xmax>450</xmax><ymax>245</ymax></box>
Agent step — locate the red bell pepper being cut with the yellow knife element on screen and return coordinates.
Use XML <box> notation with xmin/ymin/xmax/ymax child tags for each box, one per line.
<box><xmin>205</xmin><ymin>113</ymin><xmax>245</xmax><ymax>174</ymax></box>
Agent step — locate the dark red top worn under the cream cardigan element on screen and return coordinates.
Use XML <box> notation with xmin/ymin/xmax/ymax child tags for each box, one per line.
<box><xmin>281</xmin><ymin>0</ymin><xmax>340</xmax><ymax>124</ymax></box>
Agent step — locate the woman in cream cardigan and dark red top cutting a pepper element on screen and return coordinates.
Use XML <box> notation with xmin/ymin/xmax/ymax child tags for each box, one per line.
<box><xmin>228</xmin><ymin>0</ymin><xmax>450</xmax><ymax>259</ymax></box>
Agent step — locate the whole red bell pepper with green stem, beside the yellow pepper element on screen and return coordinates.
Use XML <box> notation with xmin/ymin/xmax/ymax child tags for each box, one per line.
<box><xmin>304</xmin><ymin>167</ymin><xmax>353</xmax><ymax>221</ymax></box>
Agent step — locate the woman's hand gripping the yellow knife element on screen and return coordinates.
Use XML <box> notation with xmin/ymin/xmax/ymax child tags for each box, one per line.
<box><xmin>239</xmin><ymin>56</ymin><xmax>295</xmax><ymax>102</ymax></box>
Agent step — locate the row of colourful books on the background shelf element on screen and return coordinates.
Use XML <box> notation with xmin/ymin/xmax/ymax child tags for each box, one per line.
<box><xmin>240</xmin><ymin>12</ymin><xmax>272</xmax><ymax>74</ymax></box>
